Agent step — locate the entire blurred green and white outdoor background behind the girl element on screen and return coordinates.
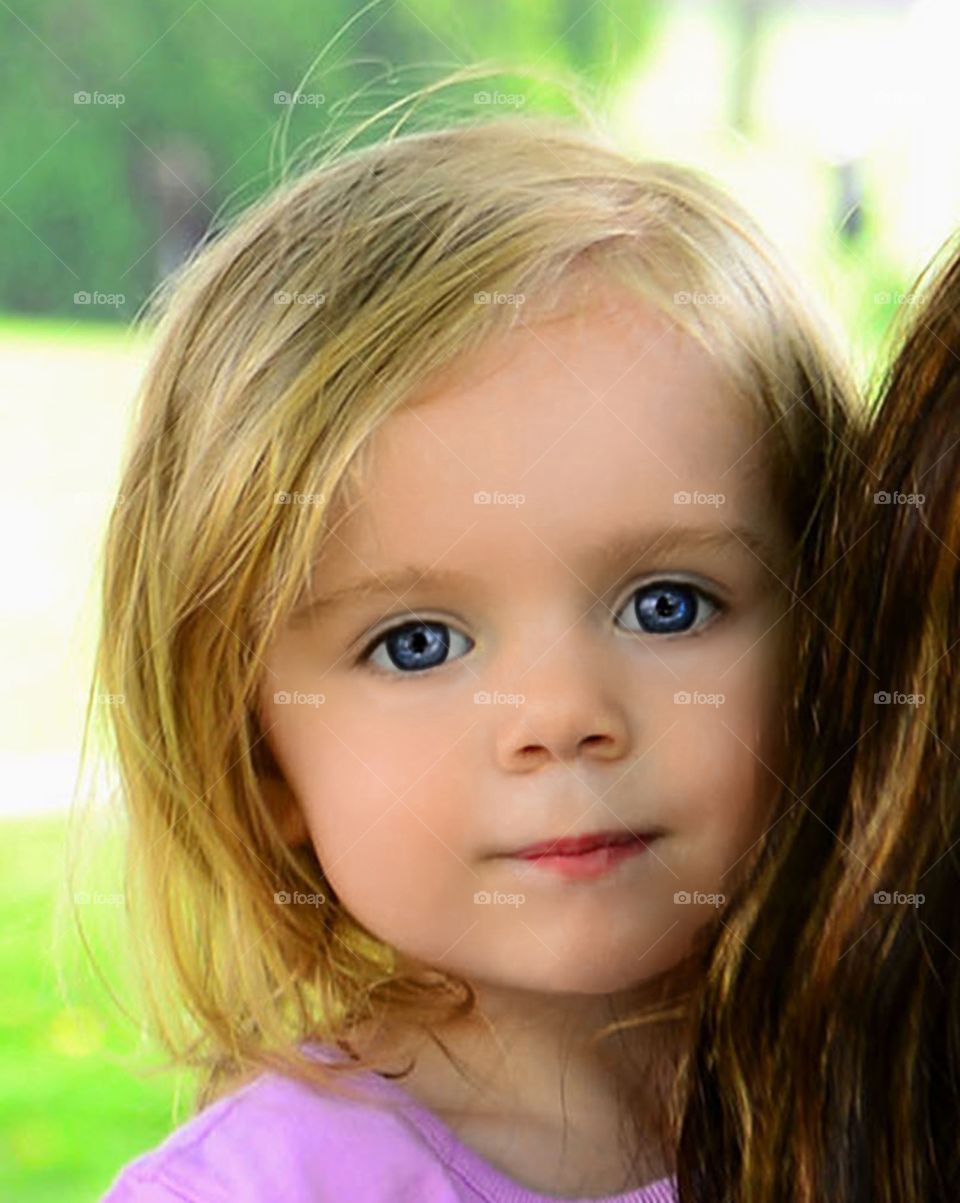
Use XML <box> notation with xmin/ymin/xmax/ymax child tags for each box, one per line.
<box><xmin>0</xmin><ymin>0</ymin><xmax>960</xmax><ymax>1203</ymax></box>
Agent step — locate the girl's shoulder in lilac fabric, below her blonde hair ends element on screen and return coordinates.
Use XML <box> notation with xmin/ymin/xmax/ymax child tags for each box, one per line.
<box><xmin>101</xmin><ymin>1073</ymin><xmax>458</xmax><ymax>1203</ymax></box>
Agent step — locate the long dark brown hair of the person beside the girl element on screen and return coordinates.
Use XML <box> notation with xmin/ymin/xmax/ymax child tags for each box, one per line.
<box><xmin>680</xmin><ymin>242</ymin><xmax>960</xmax><ymax>1203</ymax></box>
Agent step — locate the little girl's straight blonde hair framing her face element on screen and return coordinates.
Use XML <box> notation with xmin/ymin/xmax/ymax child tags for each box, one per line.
<box><xmin>75</xmin><ymin>87</ymin><xmax>852</xmax><ymax>1126</ymax></box>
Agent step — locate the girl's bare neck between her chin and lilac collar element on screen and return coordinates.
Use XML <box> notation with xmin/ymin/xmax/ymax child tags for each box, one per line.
<box><xmin>351</xmin><ymin>976</ymin><xmax>688</xmax><ymax>1177</ymax></box>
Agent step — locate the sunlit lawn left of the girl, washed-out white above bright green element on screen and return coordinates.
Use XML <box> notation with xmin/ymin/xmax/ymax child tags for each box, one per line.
<box><xmin>0</xmin><ymin>318</ymin><xmax>189</xmax><ymax>1203</ymax></box>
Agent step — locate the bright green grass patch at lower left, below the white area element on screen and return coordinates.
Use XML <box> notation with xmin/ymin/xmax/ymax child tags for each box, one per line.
<box><xmin>0</xmin><ymin>817</ymin><xmax>186</xmax><ymax>1203</ymax></box>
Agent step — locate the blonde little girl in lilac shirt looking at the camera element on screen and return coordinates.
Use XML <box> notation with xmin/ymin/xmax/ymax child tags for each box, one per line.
<box><xmin>97</xmin><ymin>108</ymin><xmax>854</xmax><ymax>1203</ymax></box>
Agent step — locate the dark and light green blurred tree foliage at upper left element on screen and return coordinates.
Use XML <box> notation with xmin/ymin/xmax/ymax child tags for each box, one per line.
<box><xmin>0</xmin><ymin>0</ymin><xmax>658</xmax><ymax>320</ymax></box>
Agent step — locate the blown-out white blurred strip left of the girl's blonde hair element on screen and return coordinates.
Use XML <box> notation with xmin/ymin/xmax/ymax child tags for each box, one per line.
<box><xmin>0</xmin><ymin>324</ymin><xmax>146</xmax><ymax>817</ymax></box>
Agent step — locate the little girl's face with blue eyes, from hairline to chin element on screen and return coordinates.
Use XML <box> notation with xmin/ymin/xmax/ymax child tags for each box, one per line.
<box><xmin>261</xmin><ymin>286</ymin><xmax>787</xmax><ymax>994</ymax></box>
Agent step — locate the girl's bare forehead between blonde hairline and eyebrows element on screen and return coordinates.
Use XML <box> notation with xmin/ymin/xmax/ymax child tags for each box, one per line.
<box><xmin>324</xmin><ymin>292</ymin><xmax>772</xmax><ymax>569</ymax></box>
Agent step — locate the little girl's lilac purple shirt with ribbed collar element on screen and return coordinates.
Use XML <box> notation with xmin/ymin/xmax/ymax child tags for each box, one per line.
<box><xmin>101</xmin><ymin>1044</ymin><xmax>676</xmax><ymax>1203</ymax></box>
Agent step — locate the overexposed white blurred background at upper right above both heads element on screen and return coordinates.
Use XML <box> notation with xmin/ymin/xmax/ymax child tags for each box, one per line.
<box><xmin>616</xmin><ymin>0</ymin><xmax>960</xmax><ymax>370</ymax></box>
